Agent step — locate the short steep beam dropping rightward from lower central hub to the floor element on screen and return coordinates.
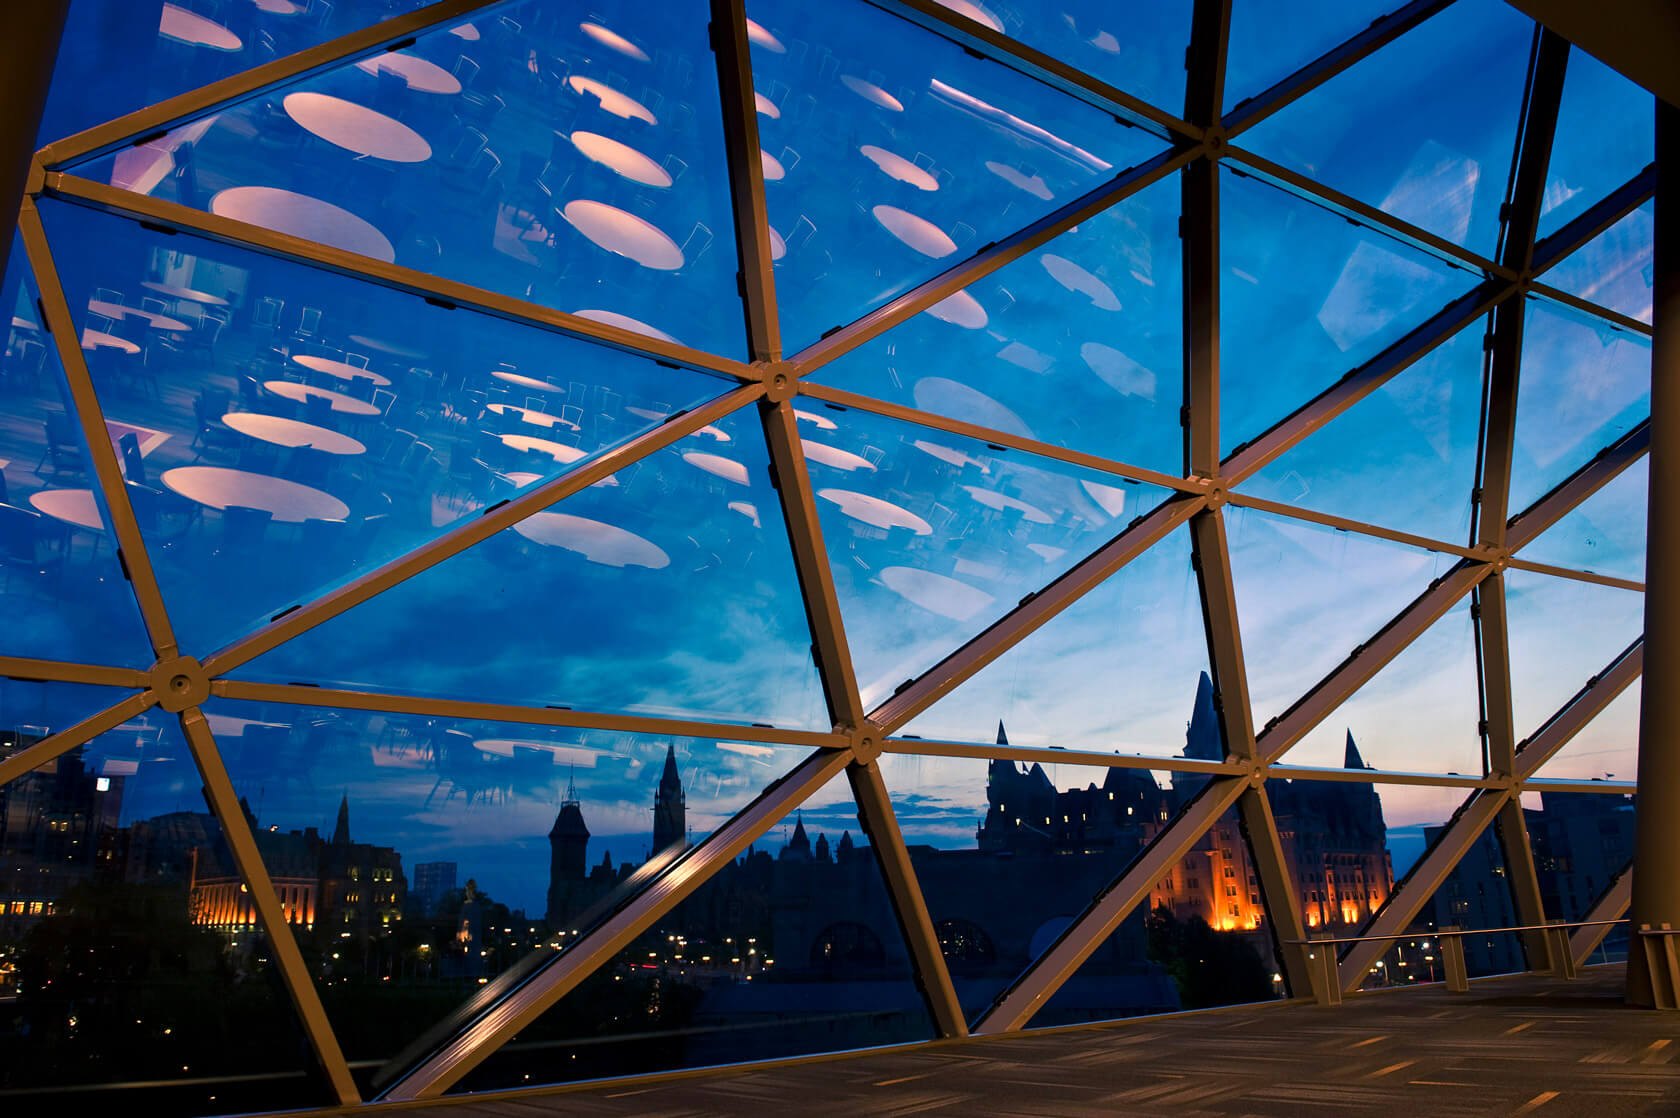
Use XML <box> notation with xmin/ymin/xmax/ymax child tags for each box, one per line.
<box><xmin>845</xmin><ymin>760</ymin><xmax>968</xmax><ymax>1037</ymax></box>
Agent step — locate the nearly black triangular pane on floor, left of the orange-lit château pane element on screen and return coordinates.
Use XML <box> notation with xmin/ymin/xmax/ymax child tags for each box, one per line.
<box><xmin>454</xmin><ymin>759</ymin><xmax>934</xmax><ymax>1093</ymax></box>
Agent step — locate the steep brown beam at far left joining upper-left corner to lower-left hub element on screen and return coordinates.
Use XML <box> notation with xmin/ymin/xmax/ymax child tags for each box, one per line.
<box><xmin>17</xmin><ymin>198</ymin><xmax>180</xmax><ymax>661</ymax></box>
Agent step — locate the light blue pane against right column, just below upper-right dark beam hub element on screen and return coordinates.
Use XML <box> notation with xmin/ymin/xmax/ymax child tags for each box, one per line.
<box><xmin>1510</xmin><ymin>298</ymin><xmax>1651</xmax><ymax>513</ymax></box>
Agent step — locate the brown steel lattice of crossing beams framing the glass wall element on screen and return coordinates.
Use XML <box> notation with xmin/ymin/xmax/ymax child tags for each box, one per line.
<box><xmin>0</xmin><ymin>0</ymin><xmax>1653</xmax><ymax>1105</ymax></box>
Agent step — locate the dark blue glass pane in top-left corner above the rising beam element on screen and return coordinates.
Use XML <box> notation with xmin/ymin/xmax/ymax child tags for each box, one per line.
<box><xmin>37</xmin><ymin>0</ymin><xmax>425</xmax><ymax>146</ymax></box>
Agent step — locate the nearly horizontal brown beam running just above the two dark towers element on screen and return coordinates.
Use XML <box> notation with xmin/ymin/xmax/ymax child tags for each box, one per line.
<box><xmin>210</xmin><ymin>679</ymin><xmax>848</xmax><ymax>748</ymax></box>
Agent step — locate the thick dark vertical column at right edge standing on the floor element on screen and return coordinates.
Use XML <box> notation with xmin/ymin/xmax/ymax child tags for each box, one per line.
<box><xmin>1628</xmin><ymin>101</ymin><xmax>1680</xmax><ymax>1005</ymax></box>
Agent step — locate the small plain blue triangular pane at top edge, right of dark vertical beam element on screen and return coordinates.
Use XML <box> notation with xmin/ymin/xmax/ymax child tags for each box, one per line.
<box><xmin>1225</xmin><ymin>0</ymin><xmax>1391</xmax><ymax>109</ymax></box>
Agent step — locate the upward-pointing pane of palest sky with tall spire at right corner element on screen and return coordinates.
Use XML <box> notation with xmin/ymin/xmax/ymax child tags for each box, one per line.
<box><xmin>902</xmin><ymin>528</ymin><xmax>1225</xmax><ymax>760</ymax></box>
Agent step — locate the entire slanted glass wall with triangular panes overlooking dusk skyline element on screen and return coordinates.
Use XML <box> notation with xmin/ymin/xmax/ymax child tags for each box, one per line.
<box><xmin>0</xmin><ymin>0</ymin><xmax>1653</xmax><ymax>1115</ymax></box>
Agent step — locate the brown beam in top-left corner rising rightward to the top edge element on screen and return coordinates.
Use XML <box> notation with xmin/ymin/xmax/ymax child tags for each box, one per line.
<box><xmin>37</xmin><ymin>0</ymin><xmax>502</xmax><ymax>166</ymax></box>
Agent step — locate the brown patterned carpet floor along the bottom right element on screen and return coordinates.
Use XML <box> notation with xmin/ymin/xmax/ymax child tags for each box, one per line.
<box><xmin>381</xmin><ymin>965</ymin><xmax>1680</xmax><ymax>1118</ymax></box>
